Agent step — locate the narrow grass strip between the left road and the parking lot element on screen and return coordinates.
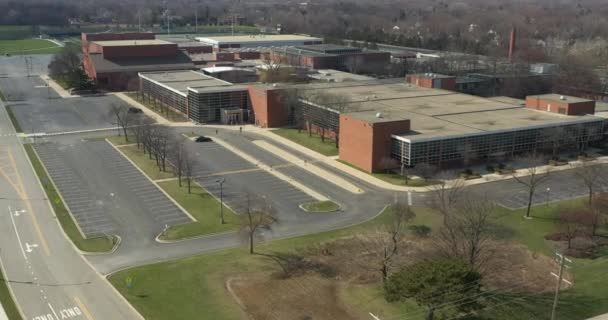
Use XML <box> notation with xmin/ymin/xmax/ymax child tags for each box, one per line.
<box><xmin>24</xmin><ymin>144</ymin><xmax>116</xmax><ymax>252</ymax></box>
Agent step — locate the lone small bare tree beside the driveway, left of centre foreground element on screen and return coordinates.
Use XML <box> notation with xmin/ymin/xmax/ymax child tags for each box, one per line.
<box><xmin>240</xmin><ymin>193</ymin><xmax>277</xmax><ymax>254</ymax></box>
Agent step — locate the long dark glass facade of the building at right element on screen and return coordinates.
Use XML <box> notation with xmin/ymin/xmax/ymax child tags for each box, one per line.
<box><xmin>391</xmin><ymin>119</ymin><xmax>605</xmax><ymax>167</ymax></box>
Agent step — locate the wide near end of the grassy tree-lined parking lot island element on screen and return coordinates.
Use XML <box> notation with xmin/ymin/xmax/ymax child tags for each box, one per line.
<box><xmin>158</xmin><ymin>181</ymin><xmax>239</xmax><ymax>240</ymax></box>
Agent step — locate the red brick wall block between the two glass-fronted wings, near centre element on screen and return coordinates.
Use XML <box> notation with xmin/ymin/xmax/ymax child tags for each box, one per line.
<box><xmin>249</xmin><ymin>86</ymin><xmax>288</xmax><ymax>128</ymax></box>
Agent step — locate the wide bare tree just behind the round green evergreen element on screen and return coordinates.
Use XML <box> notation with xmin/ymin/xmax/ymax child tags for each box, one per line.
<box><xmin>437</xmin><ymin>197</ymin><xmax>496</xmax><ymax>269</ymax></box>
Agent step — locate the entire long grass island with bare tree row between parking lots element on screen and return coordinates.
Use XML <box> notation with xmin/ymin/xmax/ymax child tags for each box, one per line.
<box><xmin>108</xmin><ymin>137</ymin><xmax>239</xmax><ymax>240</ymax></box>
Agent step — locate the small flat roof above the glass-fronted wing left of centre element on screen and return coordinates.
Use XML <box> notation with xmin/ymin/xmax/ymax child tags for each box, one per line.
<box><xmin>139</xmin><ymin>70</ymin><xmax>232</xmax><ymax>95</ymax></box>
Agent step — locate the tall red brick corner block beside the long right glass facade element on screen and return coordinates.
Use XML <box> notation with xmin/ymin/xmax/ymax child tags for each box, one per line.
<box><xmin>340</xmin><ymin>114</ymin><xmax>410</xmax><ymax>172</ymax></box>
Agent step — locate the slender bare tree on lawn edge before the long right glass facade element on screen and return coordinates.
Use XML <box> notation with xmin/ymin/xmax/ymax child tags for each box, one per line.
<box><xmin>512</xmin><ymin>155</ymin><xmax>551</xmax><ymax>218</ymax></box>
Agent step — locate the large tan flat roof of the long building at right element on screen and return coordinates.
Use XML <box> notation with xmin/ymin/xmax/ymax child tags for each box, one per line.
<box><xmin>269</xmin><ymin>79</ymin><xmax>604</xmax><ymax>142</ymax></box>
